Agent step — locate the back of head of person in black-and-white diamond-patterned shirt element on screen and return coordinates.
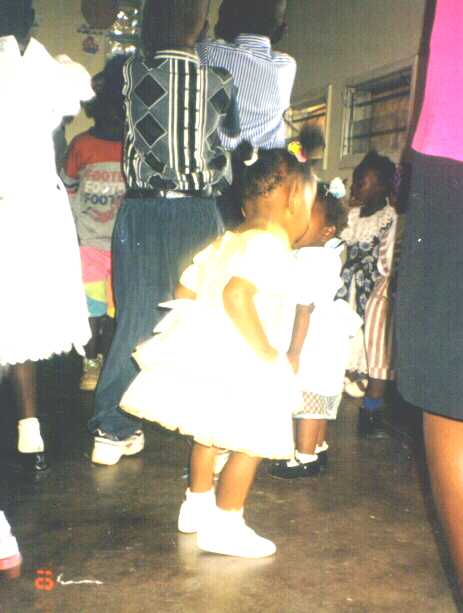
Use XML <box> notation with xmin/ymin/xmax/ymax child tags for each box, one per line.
<box><xmin>141</xmin><ymin>0</ymin><xmax>210</xmax><ymax>56</ymax></box>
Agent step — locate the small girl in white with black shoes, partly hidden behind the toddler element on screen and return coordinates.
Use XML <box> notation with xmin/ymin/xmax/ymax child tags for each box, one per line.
<box><xmin>269</xmin><ymin>179</ymin><xmax>361</xmax><ymax>479</ymax></box>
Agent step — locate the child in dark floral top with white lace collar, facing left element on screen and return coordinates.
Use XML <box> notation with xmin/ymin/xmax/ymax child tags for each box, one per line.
<box><xmin>338</xmin><ymin>151</ymin><xmax>401</xmax><ymax>437</ymax></box>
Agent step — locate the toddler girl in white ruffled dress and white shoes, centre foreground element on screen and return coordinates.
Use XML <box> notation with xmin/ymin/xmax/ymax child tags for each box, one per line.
<box><xmin>121</xmin><ymin>150</ymin><xmax>315</xmax><ymax>558</ymax></box>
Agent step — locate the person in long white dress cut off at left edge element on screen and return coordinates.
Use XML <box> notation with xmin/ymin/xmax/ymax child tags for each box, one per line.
<box><xmin>0</xmin><ymin>0</ymin><xmax>94</xmax><ymax>469</ymax></box>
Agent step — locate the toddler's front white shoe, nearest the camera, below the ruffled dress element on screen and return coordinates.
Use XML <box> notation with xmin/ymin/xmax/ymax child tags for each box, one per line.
<box><xmin>198</xmin><ymin>507</ymin><xmax>277</xmax><ymax>558</ymax></box>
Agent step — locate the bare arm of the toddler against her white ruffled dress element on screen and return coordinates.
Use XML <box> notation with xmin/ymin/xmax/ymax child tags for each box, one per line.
<box><xmin>223</xmin><ymin>277</ymin><xmax>277</xmax><ymax>360</ymax></box>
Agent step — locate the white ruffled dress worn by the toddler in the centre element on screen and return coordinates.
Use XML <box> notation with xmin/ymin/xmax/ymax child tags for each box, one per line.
<box><xmin>121</xmin><ymin>230</ymin><xmax>301</xmax><ymax>459</ymax></box>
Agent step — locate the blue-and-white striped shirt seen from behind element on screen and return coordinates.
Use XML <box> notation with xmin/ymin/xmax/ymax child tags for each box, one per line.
<box><xmin>198</xmin><ymin>34</ymin><xmax>296</xmax><ymax>151</ymax></box>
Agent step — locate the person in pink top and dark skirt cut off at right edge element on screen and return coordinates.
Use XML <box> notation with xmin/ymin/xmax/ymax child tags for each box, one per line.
<box><xmin>397</xmin><ymin>0</ymin><xmax>463</xmax><ymax>586</ymax></box>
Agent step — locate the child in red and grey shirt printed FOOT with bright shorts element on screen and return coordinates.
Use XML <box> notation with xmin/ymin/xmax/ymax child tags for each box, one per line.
<box><xmin>62</xmin><ymin>56</ymin><xmax>126</xmax><ymax>391</ymax></box>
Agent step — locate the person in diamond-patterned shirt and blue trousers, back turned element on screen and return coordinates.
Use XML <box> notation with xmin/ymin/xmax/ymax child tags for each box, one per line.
<box><xmin>89</xmin><ymin>0</ymin><xmax>239</xmax><ymax>465</ymax></box>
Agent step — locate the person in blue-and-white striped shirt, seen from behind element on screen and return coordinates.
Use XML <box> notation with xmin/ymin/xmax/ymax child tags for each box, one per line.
<box><xmin>197</xmin><ymin>0</ymin><xmax>296</xmax><ymax>227</ymax></box>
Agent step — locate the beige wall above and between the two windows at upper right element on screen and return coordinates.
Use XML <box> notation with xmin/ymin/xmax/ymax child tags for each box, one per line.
<box><xmin>284</xmin><ymin>0</ymin><xmax>425</xmax><ymax>177</ymax></box>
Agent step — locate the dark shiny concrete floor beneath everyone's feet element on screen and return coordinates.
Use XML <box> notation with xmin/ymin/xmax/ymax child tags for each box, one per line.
<box><xmin>0</xmin><ymin>358</ymin><xmax>460</xmax><ymax>613</ymax></box>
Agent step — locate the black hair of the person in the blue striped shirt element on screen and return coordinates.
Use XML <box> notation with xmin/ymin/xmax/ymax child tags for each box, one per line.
<box><xmin>215</xmin><ymin>0</ymin><xmax>283</xmax><ymax>42</ymax></box>
